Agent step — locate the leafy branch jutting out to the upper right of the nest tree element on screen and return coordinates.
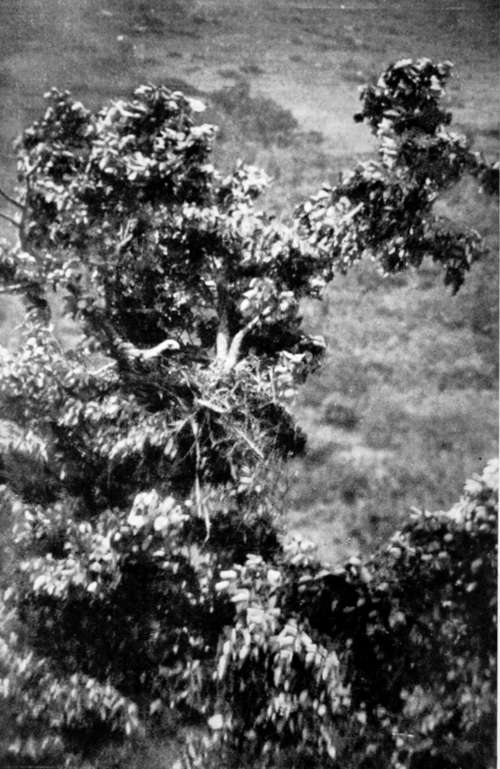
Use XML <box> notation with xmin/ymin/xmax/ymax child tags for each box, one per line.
<box><xmin>298</xmin><ymin>59</ymin><xmax>498</xmax><ymax>291</ymax></box>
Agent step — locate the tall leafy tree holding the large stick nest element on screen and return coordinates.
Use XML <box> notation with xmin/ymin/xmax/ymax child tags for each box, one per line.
<box><xmin>0</xmin><ymin>60</ymin><xmax>495</xmax><ymax>768</ymax></box>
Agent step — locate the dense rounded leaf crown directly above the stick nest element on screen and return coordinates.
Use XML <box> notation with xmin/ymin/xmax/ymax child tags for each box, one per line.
<box><xmin>5</xmin><ymin>86</ymin><xmax>325</xmax><ymax>366</ymax></box>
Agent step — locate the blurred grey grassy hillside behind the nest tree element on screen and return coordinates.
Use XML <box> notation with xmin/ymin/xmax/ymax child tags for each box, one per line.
<box><xmin>0</xmin><ymin>0</ymin><xmax>500</xmax><ymax>561</ymax></box>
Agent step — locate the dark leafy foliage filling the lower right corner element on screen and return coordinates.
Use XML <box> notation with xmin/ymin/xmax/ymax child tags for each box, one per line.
<box><xmin>205</xmin><ymin>462</ymin><xmax>498</xmax><ymax>769</ymax></box>
